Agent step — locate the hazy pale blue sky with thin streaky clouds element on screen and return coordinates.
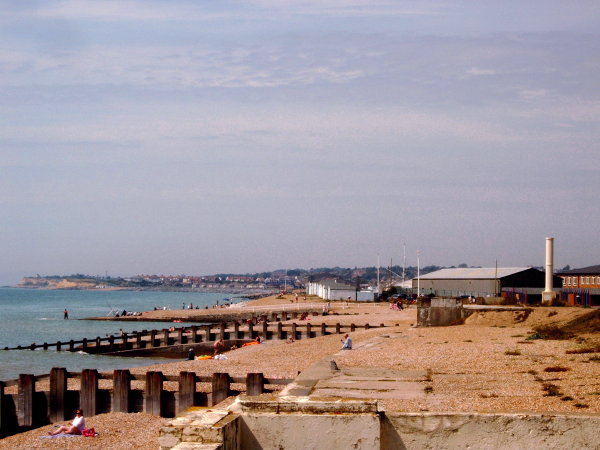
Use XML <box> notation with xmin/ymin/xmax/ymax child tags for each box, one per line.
<box><xmin>0</xmin><ymin>0</ymin><xmax>600</xmax><ymax>284</ymax></box>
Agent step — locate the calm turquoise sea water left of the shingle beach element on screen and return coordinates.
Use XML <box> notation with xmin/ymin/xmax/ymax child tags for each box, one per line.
<box><xmin>0</xmin><ymin>288</ymin><xmax>239</xmax><ymax>380</ymax></box>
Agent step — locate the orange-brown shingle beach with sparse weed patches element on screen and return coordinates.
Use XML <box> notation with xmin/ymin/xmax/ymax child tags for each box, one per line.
<box><xmin>0</xmin><ymin>296</ymin><xmax>600</xmax><ymax>448</ymax></box>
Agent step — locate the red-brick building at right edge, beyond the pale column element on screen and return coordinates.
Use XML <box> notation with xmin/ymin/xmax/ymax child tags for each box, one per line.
<box><xmin>558</xmin><ymin>265</ymin><xmax>600</xmax><ymax>306</ymax></box>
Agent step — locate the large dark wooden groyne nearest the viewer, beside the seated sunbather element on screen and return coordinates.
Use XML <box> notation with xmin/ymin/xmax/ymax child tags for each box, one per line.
<box><xmin>0</xmin><ymin>368</ymin><xmax>292</xmax><ymax>435</ymax></box>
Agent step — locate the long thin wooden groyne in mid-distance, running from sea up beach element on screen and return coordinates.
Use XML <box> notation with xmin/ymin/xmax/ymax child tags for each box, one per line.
<box><xmin>4</xmin><ymin>318</ymin><xmax>384</xmax><ymax>353</ymax></box>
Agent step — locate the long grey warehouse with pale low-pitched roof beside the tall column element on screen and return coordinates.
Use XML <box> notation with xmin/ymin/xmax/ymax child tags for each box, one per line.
<box><xmin>412</xmin><ymin>267</ymin><xmax>563</xmax><ymax>303</ymax></box>
